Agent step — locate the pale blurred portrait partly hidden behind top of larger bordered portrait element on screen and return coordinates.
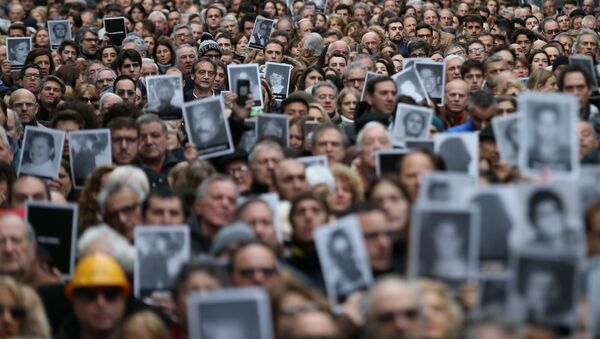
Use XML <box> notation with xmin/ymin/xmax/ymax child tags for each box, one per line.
<box><xmin>419</xmin><ymin>171</ymin><xmax>476</xmax><ymax>206</ymax></box>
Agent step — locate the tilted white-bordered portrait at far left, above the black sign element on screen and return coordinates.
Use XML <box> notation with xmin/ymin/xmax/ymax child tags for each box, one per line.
<box><xmin>19</xmin><ymin>126</ymin><xmax>65</xmax><ymax>179</ymax></box>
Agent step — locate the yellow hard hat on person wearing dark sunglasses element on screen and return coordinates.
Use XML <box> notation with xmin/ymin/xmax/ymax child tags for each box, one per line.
<box><xmin>66</xmin><ymin>253</ymin><xmax>130</xmax><ymax>298</ymax></box>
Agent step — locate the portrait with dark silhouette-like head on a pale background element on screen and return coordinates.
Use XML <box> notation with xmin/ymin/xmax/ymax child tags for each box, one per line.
<box><xmin>434</xmin><ymin>133</ymin><xmax>479</xmax><ymax>178</ymax></box>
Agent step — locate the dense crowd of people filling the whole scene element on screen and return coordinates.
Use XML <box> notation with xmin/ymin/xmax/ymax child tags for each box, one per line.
<box><xmin>0</xmin><ymin>0</ymin><xmax>600</xmax><ymax>339</ymax></box>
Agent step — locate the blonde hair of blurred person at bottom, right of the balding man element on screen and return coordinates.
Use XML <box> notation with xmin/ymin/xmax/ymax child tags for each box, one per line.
<box><xmin>416</xmin><ymin>279</ymin><xmax>464</xmax><ymax>339</ymax></box>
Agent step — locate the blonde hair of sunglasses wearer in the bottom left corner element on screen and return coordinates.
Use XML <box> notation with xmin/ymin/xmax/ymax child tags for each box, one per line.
<box><xmin>0</xmin><ymin>276</ymin><xmax>51</xmax><ymax>338</ymax></box>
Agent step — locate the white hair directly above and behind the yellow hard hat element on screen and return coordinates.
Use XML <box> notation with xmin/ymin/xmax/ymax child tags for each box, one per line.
<box><xmin>77</xmin><ymin>224</ymin><xmax>135</xmax><ymax>272</ymax></box>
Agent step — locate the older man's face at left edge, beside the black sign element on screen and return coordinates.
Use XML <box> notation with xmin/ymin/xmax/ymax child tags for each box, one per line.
<box><xmin>0</xmin><ymin>215</ymin><xmax>35</xmax><ymax>277</ymax></box>
